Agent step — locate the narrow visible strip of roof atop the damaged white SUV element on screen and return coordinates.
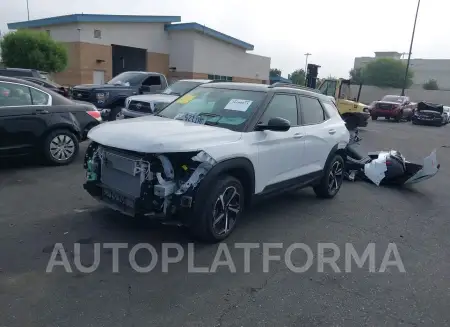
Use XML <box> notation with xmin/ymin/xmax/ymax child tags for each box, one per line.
<box><xmin>202</xmin><ymin>82</ymin><xmax>329</xmax><ymax>101</ymax></box>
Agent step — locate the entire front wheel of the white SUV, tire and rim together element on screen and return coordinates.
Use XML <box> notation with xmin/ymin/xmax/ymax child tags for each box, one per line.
<box><xmin>191</xmin><ymin>175</ymin><xmax>244</xmax><ymax>243</ymax></box>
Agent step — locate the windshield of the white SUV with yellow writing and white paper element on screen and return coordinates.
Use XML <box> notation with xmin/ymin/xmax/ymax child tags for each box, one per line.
<box><xmin>158</xmin><ymin>86</ymin><xmax>266</xmax><ymax>131</ymax></box>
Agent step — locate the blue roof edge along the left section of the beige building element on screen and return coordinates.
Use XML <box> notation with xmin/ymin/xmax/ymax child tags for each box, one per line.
<box><xmin>8</xmin><ymin>14</ymin><xmax>181</xmax><ymax>30</ymax></box>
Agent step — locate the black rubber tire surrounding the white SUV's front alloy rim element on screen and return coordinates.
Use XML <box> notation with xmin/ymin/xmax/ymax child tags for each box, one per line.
<box><xmin>191</xmin><ymin>176</ymin><xmax>245</xmax><ymax>243</ymax></box>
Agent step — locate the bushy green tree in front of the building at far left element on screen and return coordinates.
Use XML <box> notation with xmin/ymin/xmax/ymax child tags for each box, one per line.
<box><xmin>0</xmin><ymin>30</ymin><xmax>68</xmax><ymax>73</ymax></box>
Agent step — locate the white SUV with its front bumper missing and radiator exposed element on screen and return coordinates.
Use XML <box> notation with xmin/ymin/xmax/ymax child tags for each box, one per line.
<box><xmin>84</xmin><ymin>82</ymin><xmax>350</xmax><ymax>242</ymax></box>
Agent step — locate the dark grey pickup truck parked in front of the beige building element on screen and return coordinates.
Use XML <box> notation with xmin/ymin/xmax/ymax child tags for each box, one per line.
<box><xmin>70</xmin><ymin>71</ymin><xmax>167</xmax><ymax>121</ymax></box>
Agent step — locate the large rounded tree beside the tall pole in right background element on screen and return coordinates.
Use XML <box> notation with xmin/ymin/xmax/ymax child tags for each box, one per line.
<box><xmin>364</xmin><ymin>58</ymin><xmax>414</xmax><ymax>88</ymax></box>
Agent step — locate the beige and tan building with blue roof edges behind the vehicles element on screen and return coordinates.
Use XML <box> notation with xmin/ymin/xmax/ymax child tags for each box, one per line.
<box><xmin>8</xmin><ymin>14</ymin><xmax>270</xmax><ymax>85</ymax></box>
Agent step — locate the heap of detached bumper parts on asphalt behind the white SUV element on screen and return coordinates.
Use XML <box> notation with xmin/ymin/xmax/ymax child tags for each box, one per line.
<box><xmin>345</xmin><ymin>133</ymin><xmax>440</xmax><ymax>186</ymax></box>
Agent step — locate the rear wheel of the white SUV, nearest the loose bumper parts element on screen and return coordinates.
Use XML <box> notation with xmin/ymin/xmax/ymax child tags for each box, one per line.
<box><xmin>313</xmin><ymin>154</ymin><xmax>344</xmax><ymax>199</ymax></box>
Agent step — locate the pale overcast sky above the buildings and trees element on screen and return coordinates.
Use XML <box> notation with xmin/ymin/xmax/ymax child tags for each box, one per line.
<box><xmin>0</xmin><ymin>0</ymin><xmax>450</xmax><ymax>77</ymax></box>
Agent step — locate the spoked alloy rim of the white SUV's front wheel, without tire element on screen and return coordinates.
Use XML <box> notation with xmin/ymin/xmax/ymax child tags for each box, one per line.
<box><xmin>212</xmin><ymin>186</ymin><xmax>241</xmax><ymax>235</ymax></box>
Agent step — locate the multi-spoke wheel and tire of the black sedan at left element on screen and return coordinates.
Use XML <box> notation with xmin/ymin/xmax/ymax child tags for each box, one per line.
<box><xmin>43</xmin><ymin>129</ymin><xmax>79</xmax><ymax>166</ymax></box>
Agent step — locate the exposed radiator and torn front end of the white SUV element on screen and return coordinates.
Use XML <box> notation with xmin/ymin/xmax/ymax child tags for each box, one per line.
<box><xmin>84</xmin><ymin>142</ymin><xmax>216</xmax><ymax>222</ymax></box>
